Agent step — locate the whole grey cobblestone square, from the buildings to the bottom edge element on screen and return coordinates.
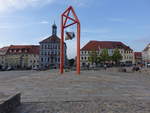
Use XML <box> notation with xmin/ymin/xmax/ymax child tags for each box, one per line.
<box><xmin>0</xmin><ymin>70</ymin><xmax>150</xmax><ymax>113</ymax></box>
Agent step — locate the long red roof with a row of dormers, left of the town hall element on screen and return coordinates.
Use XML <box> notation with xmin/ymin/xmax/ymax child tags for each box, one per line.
<box><xmin>7</xmin><ymin>45</ymin><xmax>40</xmax><ymax>54</ymax></box>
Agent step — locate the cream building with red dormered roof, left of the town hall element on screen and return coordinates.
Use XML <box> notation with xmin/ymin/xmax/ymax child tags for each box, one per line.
<box><xmin>0</xmin><ymin>45</ymin><xmax>39</xmax><ymax>69</ymax></box>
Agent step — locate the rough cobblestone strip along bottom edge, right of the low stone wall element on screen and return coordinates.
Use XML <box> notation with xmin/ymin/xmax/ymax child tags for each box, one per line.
<box><xmin>13</xmin><ymin>99</ymin><xmax>150</xmax><ymax>113</ymax></box>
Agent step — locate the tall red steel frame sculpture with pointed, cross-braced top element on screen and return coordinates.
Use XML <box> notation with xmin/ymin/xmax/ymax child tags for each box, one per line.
<box><xmin>60</xmin><ymin>6</ymin><xmax>80</xmax><ymax>74</ymax></box>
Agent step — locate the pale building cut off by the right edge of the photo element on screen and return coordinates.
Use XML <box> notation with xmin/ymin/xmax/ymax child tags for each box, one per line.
<box><xmin>142</xmin><ymin>44</ymin><xmax>150</xmax><ymax>64</ymax></box>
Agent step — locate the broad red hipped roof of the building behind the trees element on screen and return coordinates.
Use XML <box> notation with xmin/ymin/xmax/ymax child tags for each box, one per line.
<box><xmin>81</xmin><ymin>41</ymin><xmax>133</xmax><ymax>51</ymax></box>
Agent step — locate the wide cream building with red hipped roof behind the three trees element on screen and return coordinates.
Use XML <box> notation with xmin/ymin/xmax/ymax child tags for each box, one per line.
<box><xmin>80</xmin><ymin>41</ymin><xmax>134</xmax><ymax>65</ymax></box>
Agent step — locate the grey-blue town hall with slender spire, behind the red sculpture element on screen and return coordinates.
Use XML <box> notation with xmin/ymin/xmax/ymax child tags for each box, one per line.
<box><xmin>40</xmin><ymin>24</ymin><xmax>67</xmax><ymax>68</ymax></box>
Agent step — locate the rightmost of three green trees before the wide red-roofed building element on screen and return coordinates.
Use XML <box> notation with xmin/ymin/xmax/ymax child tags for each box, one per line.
<box><xmin>111</xmin><ymin>49</ymin><xmax>122</xmax><ymax>64</ymax></box>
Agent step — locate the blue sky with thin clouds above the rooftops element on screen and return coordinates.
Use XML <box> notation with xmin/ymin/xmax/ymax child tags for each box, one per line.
<box><xmin>0</xmin><ymin>0</ymin><xmax>150</xmax><ymax>58</ymax></box>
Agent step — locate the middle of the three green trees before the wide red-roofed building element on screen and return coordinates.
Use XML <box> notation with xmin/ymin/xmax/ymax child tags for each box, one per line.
<box><xmin>100</xmin><ymin>48</ymin><xmax>110</xmax><ymax>63</ymax></box>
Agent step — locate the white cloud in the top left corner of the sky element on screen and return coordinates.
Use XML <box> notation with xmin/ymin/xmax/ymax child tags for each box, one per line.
<box><xmin>0</xmin><ymin>0</ymin><xmax>54</xmax><ymax>12</ymax></box>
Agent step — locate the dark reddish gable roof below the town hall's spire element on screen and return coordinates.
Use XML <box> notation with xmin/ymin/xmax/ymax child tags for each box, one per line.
<box><xmin>40</xmin><ymin>35</ymin><xmax>60</xmax><ymax>43</ymax></box>
